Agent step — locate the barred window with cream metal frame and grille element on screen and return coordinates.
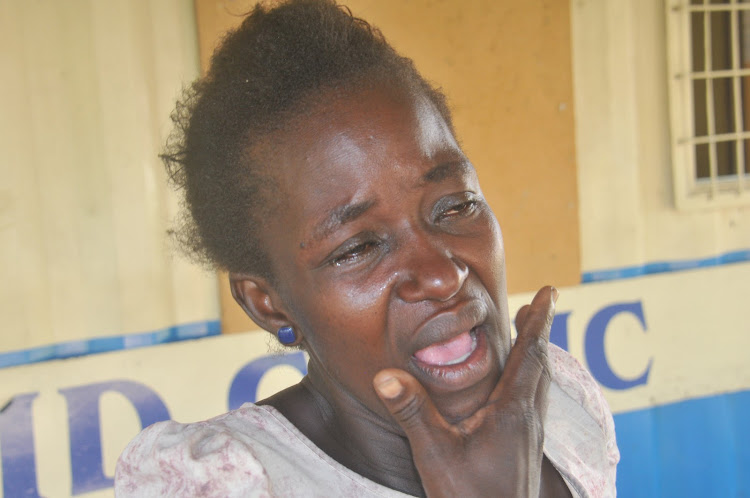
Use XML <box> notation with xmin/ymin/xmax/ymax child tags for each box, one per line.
<box><xmin>666</xmin><ymin>0</ymin><xmax>750</xmax><ymax>209</ymax></box>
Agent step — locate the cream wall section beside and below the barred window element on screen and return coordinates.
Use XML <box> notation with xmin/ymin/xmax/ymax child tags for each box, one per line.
<box><xmin>571</xmin><ymin>0</ymin><xmax>750</xmax><ymax>272</ymax></box>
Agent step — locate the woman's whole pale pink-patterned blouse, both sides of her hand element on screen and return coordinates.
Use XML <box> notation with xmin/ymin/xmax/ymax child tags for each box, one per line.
<box><xmin>115</xmin><ymin>346</ymin><xmax>619</xmax><ymax>498</ymax></box>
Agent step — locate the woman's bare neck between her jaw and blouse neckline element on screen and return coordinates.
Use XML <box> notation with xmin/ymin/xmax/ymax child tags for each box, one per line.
<box><xmin>262</xmin><ymin>362</ymin><xmax>424</xmax><ymax>496</ymax></box>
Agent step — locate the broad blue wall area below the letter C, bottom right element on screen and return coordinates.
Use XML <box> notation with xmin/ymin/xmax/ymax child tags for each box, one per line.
<box><xmin>615</xmin><ymin>391</ymin><xmax>750</xmax><ymax>498</ymax></box>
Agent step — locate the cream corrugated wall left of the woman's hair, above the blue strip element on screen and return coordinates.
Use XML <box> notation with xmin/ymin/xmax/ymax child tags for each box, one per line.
<box><xmin>0</xmin><ymin>0</ymin><xmax>219</xmax><ymax>352</ymax></box>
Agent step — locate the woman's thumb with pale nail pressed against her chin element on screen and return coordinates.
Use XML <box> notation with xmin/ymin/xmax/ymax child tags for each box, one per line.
<box><xmin>373</xmin><ymin>369</ymin><xmax>450</xmax><ymax>455</ymax></box>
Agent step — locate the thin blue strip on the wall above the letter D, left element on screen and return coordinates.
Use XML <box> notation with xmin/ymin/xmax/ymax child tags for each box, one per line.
<box><xmin>0</xmin><ymin>320</ymin><xmax>221</xmax><ymax>368</ymax></box>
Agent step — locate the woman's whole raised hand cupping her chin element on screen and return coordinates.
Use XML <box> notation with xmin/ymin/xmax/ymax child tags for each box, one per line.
<box><xmin>373</xmin><ymin>287</ymin><xmax>557</xmax><ymax>498</ymax></box>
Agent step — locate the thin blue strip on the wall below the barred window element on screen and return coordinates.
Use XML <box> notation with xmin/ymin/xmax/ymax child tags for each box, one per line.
<box><xmin>581</xmin><ymin>249</ymin><xmax>750</xmax><ymax>284</ymax></box>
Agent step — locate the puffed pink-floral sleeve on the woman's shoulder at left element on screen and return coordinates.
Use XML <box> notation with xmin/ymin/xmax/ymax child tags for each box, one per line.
<box><xmin>115</xmin><ymin>405</ymin><xmax>278</xmax><ymax>497</ymax></box>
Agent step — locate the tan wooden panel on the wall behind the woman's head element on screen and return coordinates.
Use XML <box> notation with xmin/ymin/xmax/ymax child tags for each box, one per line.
<box><xmin>196</xmin><ymin>0</ymin><xmax>580</xmax><ymax>331</ymax></box>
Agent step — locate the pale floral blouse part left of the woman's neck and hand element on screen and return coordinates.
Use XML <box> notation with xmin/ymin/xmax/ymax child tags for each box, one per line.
<box><xmin>115</xmin><ymin>403</ymin><xmax>414</xmax><ymax>498</ymax></box>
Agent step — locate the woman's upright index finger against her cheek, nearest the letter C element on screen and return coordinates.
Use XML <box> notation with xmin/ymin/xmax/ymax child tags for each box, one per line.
<box><xmin>492</xmin><ymin>286</ymin><xmax>558</xmax><ymax>400</ymax></box>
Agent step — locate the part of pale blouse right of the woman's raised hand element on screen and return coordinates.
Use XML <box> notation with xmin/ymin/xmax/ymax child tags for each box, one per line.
<box><xmin>545</xmin><ymin>344</ymin><xmax>620</xmax><ymax>497</ymax></box>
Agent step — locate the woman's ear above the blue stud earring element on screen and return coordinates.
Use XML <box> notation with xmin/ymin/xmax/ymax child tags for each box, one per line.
<box><xmin>229</xmin><ymin>273</ymin><xmax>299</xmax><ymax>335</ymax></box>
